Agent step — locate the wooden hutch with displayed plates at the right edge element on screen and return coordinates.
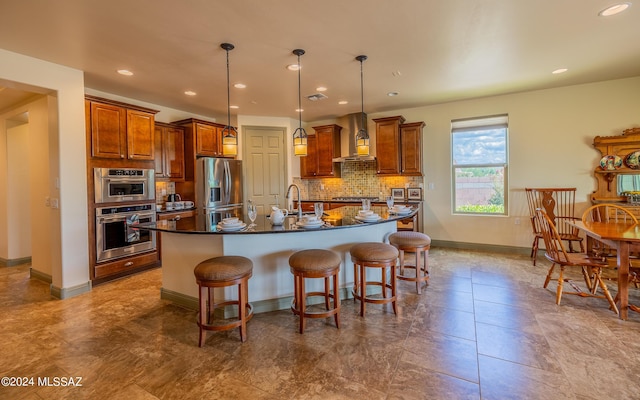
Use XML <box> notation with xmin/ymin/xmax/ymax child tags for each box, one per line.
<box><xmin>591</xmin><ymin>128</ymin><xmax>640</xmax><ymax>211</ymax></box>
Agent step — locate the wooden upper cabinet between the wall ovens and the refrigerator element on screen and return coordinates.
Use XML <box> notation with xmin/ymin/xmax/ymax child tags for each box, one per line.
<box><xmin>154</xmin><ymin>122</ymin><xmax>184</xmax><ymax>182</ymax></box>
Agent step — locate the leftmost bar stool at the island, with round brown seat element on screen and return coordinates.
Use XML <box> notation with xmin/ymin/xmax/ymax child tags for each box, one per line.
<box><xmin>193</xmin><ymin>256</ymin><xmax>253</xmax><ymax>347</ymax></box>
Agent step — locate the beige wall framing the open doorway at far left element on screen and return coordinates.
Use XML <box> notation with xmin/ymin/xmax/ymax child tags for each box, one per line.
<box><xmin>0</xmin><ymin>49</ymin><xmax>89</xmax><ymax>296</ymax></box>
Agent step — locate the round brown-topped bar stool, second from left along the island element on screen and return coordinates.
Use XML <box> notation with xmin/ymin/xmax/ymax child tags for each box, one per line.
<box><xmin>289</xmin><ymin>249</ymin><xmax>340</xmax><ymax>333</ymax></box>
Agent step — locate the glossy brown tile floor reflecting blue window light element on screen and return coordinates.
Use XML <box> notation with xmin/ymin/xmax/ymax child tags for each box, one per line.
<box><xmin>0</xmin><ymin>249</ymin><xmax>640</xmax><ymax>400</ymax></box>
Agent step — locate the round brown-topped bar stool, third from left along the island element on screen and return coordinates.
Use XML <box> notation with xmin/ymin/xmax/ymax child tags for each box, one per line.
<box><xmin>350</xmin><ymin>242</ymin><xmax>398</xmax><ymax>317</ymax></box>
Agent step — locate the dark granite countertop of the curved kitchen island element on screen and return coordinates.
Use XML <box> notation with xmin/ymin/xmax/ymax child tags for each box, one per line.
<box><xmin>138</xmin><ymin>206</ymin><xmax>418</xmax><ymax>234</ymax></box>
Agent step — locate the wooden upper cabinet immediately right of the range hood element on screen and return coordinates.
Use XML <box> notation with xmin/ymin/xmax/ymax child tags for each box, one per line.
<box><xmin>373</xmin><ymin>115</ymin><xmax>424</xmax><ymax>176</ymax></box>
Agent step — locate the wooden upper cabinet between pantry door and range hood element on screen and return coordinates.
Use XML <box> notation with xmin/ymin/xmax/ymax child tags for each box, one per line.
<box><xmin>300</xmin><ymin>124</ymin><xmax>342</xmax><ymax>179</ymax></box>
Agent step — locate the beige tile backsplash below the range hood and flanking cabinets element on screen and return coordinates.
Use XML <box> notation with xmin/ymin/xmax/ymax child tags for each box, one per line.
<box><xmin>293</xmin><ymin>161</ymin><xmax>424</xmax><ymax>200</ymax></box>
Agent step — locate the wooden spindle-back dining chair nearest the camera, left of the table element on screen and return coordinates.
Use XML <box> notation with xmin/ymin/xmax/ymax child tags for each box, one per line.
<box><xmin>535</xmin><ymin>208</ymin><xmax>618</xmax><ymax>314</ymax></box>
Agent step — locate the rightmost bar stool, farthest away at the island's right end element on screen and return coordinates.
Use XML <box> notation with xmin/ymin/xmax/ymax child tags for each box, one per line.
<box><xmin>389</xmin><ymin>231</ymin><xmax>431</xmax><ymax>294</ymax></box>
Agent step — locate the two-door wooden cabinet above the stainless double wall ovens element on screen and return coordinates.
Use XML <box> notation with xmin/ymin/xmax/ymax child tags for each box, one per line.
<box><xmin>86</xmin><ymin>96</ymin><xmax>157</xmax><ymax>160</ymax></box>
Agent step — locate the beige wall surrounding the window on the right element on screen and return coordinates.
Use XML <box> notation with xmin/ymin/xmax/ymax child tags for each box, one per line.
<box><xmin>369</xmin><ymin>77</ymin><xmax>640</xmax><ymax>247</ymax></box>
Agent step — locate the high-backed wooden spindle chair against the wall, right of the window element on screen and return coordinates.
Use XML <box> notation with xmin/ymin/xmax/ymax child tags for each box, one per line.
<box><xmin>525</xmin><ymin>188</ymin><xmax>585</xmax><ymax>265</ymax></box>
